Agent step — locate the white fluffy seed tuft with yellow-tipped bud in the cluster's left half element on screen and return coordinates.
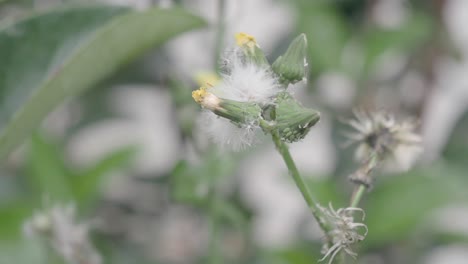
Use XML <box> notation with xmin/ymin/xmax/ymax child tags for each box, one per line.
<box><xmin>192</xmin><ymin>36</ymin><xmax>281</xmax><ymax>150</ymax></box>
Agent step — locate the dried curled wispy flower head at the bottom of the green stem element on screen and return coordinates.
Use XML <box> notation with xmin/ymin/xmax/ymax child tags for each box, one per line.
<box><xmin>319</xmin><ymin>203</ymin><xmax>368</xmax><ymax>264</ymax></box>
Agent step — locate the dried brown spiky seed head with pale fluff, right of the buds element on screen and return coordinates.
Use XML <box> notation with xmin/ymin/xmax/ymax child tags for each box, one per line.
<box><xmin>347</xmin><ymin>111</ymin><xmax>422</xmax><ymax>170</ymax></box>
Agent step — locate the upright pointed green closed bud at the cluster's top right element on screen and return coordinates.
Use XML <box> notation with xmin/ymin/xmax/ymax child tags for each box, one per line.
<box><xmin>272</xmin><ymin>34</ymin><xmax>307</xmax><ymax>85</ymax></box>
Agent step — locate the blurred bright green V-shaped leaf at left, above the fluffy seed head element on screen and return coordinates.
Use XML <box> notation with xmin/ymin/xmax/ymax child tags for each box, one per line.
<box><xmin>27</xmin><ymin>134</ymin><xmax>136</xmax><ymax>207</ymax></box>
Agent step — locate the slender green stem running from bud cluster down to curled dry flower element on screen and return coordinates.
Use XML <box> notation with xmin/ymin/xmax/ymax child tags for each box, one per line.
<box><xmin>260</xmin><ymin>120</ymin><xmax>332</xmax><ymax>235</ymax></box>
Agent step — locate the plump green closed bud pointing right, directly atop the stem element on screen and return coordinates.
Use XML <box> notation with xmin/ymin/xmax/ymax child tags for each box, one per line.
<box><xmin>275</xmin><ymin>92</ymin><xmax>320</xmax><ymax>143</ymax></box>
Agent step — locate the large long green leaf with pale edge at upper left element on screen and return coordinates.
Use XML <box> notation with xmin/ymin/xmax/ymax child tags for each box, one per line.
<box><xmin>0</xmin><ymin>6</ymin><xmax>204</xmax><ymax>158</ymax></box>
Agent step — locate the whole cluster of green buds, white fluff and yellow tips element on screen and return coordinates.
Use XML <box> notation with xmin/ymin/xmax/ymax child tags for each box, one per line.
<box><xmin>192</xmin><ymin>33</ymin><xmax>320</xmax><ymax>149</ymax></box>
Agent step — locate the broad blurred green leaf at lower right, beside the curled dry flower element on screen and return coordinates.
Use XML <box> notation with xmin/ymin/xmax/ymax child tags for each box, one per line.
<box><xmin>363</xmin><ymin>165</ymin><xmax>468</xmax><ymax>247</ymax></box>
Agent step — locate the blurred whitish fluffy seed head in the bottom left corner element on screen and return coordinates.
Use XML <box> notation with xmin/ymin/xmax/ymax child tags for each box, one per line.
<box><xmin>23</xmin><ymin>205</ymin><xmax>101</xmax><ymax>264</ymax></box>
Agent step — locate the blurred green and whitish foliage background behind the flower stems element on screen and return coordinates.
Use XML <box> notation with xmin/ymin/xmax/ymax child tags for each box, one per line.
<box><xmin>0</xmin><ymin>0</ymin><xmax>468</xmax><ymax>264</ymax></box>
